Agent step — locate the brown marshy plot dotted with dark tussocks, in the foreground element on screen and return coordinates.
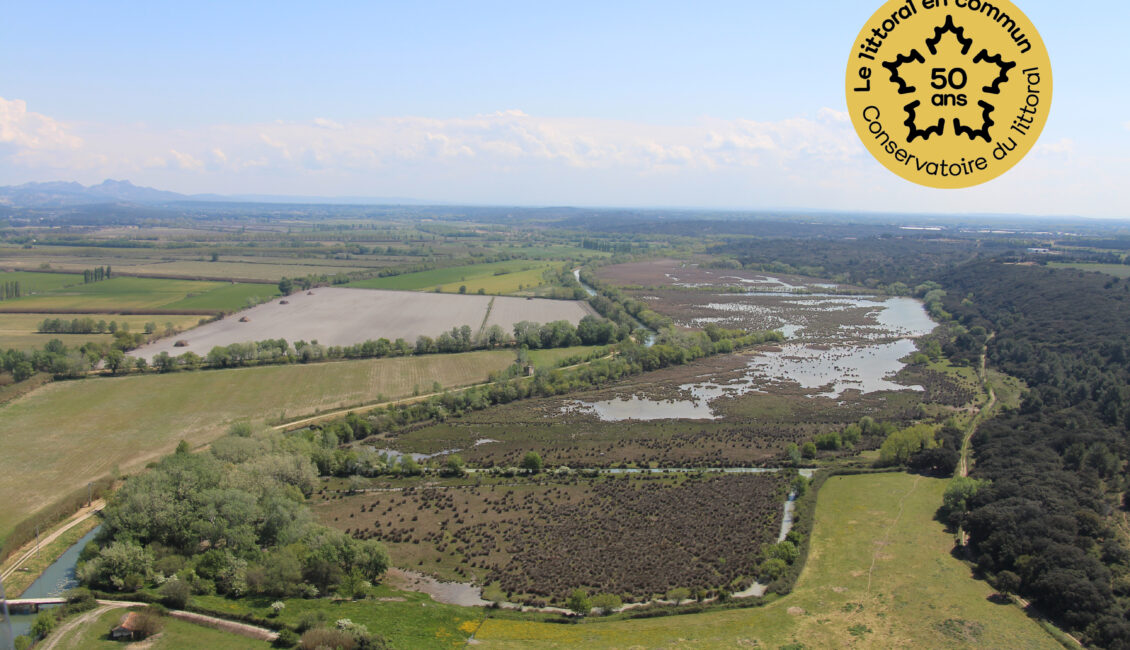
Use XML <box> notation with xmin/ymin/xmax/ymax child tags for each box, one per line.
<box><xmin>314</xmin><ymin>474</ymin><xmax>789</xmax><ymax>605</ymax></box>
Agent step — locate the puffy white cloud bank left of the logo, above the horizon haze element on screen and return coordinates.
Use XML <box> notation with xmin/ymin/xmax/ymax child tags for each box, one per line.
<box><xmin>0</xmin><ymin>101</ymin><xmax>859</xmax><ymax>183</ymax></box>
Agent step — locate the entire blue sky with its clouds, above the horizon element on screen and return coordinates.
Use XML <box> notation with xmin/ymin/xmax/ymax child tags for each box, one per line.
<box><xmin>0</xmin><ymin>0</ymin><xmax>1130</xmax><ymax>217</ymax></box>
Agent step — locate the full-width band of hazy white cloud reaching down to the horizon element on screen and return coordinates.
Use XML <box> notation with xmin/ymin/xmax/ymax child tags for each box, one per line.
<box><xmin>0</xmin><ymin>98</ymin><xmax>1130</xmax><ymax>216</ymax></box>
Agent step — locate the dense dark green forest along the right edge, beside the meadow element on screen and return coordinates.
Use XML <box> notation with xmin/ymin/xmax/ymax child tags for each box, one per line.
<box><xmin>939</xmin><ymin>261</ymin><xmax>1130</xmax><ymax>648</ymax></box>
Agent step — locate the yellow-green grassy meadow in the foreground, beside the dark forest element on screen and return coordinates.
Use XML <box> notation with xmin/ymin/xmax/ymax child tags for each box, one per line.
<box><xmin>475</xmin><ymin>474</ymin><xmax>1061</xmax><ymax>649</ymax></box>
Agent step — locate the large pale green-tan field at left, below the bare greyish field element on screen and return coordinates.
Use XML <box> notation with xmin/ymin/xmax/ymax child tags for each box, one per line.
<box><xmin>0</xmin><ymin>350</ymin><xmax>514</xmax><ymax>544</ymax></box>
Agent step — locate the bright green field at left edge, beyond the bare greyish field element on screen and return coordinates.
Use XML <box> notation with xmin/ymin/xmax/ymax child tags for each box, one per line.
<box><xmin>0</xmin><ymin>274</ymin><xmax>278</xmax><ymax>312</ymax></box>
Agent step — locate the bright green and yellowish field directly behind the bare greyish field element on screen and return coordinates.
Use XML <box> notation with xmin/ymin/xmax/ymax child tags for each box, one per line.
<box><xmin>347</xmin><ymin>260</ymin><xmax>550</xmax><ymax>294</ymax></box>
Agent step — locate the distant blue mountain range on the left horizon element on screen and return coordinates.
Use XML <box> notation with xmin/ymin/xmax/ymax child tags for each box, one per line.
<box><xmin>0</xmin><ymin>179</ymin><xmax>428</xmax><ymax>208</ymax></box>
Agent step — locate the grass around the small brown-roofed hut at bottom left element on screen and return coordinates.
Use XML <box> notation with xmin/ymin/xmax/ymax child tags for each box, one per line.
<box><xmin>48</xmin><ymin>608</ymin><xmax>271</xmax><ymax>650</ymax></box>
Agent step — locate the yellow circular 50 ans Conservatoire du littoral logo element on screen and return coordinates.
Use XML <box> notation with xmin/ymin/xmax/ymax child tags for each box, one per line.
<box><xmin>848</xmin><ymin>0</ymin><xmax>1052</xmax><ymax>188</ymax></box>
